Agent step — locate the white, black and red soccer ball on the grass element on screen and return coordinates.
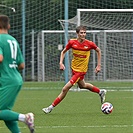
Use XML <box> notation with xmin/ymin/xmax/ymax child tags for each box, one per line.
<box><xmin>101</xmin><ymin>102</ymin><xmax>113</xmax><ymax>114</ymax></box>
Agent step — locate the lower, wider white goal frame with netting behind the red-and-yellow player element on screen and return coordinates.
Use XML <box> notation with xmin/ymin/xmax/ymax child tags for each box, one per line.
<box><xmin>38</xmin><ymin>30</ymin><xmax>133</xmax><ymax>81</ymax></box>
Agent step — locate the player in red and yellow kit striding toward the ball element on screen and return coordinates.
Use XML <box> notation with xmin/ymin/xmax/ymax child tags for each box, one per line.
<box><xmin>42</xmin><ymin>25</ymin><xmax>106</xmax><ymax>114</ymax></box>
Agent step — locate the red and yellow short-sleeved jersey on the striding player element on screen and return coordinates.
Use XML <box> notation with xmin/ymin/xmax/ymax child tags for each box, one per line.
<box><xmin>66</xmin><ymin>39</ymin><xmax>97</xmax><ymax>72</ymax></box>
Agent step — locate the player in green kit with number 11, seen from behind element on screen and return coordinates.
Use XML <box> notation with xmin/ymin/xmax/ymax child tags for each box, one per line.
<box><xmin>0</xmin><ymin>15</ymin><xmax>34</xmax><ymax>133</ymax></box>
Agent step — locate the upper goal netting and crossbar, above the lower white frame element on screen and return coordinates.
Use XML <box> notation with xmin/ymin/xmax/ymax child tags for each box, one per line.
<box><xmin>59</xmin><ymin>9</ymin><xmax>133</xmax><ymax>30</ymax></box>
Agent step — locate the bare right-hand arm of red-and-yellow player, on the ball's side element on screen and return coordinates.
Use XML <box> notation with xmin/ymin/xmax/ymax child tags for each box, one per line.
<box><xmin>95</xmin><ymin>47</ymin><xmax>101</xmax><ymax>73</ymax></box>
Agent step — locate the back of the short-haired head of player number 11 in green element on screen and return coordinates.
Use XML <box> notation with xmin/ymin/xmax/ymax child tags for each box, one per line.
<box><xmin>0</xmin><ymin>15</ymin><xmax>10</xmax><ymax>30</ymax></box>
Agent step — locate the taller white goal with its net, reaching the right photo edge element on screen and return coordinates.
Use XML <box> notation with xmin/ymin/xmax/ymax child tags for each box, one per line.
<box><xmin>59</xmin><ymin>9</ymin><xmax>133</xmax><ymax>81</ymax></box>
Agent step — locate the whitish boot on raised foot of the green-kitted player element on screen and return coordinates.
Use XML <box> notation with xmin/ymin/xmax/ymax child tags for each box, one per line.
<box><xmin>25</xmin><ymin>113</ymin><xmax>35</xmax><ymax>133</ymax></box>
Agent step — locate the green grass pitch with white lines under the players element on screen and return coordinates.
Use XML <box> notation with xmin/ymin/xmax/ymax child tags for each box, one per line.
<box><xmin>0</xmin><ymin>82</ymin><xmax>133</xmax><ymax>133</ymax></box>
